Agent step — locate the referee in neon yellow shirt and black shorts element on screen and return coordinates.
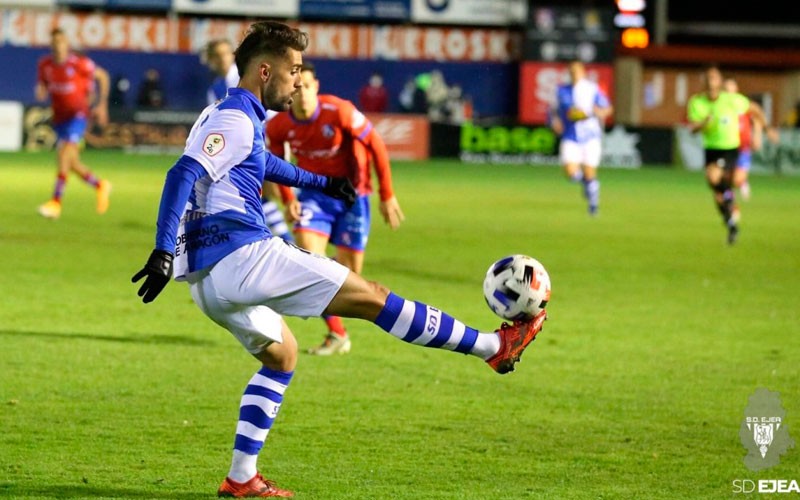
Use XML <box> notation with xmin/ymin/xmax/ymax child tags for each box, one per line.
<box><xmin>687</xmin><ymin>66</ymin><xmax>767</xmax><ymax>245</ymax></box>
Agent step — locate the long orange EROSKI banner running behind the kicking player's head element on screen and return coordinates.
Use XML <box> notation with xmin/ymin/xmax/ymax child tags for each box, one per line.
<box><xmin>0</xmin><ymin>9</ymin><xmax>521</xmax><ymax>62</ymax></box>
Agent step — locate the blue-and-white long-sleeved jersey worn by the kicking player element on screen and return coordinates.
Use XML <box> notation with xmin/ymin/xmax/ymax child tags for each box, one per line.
<box><xmin>156</xmin><ymin>88</ymin><xmax>327</xmax><ymax>279</ymax></box>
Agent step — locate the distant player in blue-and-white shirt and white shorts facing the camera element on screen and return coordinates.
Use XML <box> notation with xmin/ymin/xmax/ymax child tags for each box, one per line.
<box><xmin>550</xmin><ymin>61</ymin><xmax>614</xmax><ymax>215</ymax></box>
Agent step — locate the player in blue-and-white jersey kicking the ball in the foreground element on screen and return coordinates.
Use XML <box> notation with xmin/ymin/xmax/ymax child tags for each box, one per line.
<box><xmin>132</xmin><ymin>21</ymin><xmax>546</xmax><ymax>497</ymax></box>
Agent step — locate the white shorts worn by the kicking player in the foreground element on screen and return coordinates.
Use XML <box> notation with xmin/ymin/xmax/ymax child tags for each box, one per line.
<box><xmin>186</xmin><ymin>238</ymin><xmax>350</xmax><ymax>354</ymax></box>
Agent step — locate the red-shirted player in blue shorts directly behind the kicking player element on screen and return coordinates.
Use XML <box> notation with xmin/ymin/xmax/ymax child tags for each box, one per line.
<box><xmin>267</xmin><ymin>64</ymin><xmax>404</xmax><ymax>355</ymax></box>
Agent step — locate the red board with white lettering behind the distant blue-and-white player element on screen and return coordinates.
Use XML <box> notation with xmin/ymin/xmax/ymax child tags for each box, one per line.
<box><xmin>519</xmin><ymin>61</ymin><xmax>614</xmax><ymax>125</ymax></box>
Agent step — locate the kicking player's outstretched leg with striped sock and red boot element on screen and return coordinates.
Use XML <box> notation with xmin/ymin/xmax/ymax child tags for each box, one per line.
<box><xmin>326</xmin><ymin>273</ymin><xmax>546</xmax><ymax>373</ymax></box>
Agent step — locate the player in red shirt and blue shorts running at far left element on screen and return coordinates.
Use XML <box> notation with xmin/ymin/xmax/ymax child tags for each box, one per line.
<box><xmin>35</xmin><ymin>28</ymin><xmax>111</xmax><ymax>219</ymax></box>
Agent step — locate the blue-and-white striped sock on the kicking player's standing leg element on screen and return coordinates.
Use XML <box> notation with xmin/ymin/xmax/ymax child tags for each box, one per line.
<box><xmin>228</xmin><ymin>367</ymin><xmax>294</xmax><ymax>483</ymax></box>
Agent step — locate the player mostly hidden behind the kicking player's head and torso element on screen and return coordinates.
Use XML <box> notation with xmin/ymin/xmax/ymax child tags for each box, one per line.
<box><xmin>205</xmin><ymin>38</ymin><xmax>294</xmax><ymax>241</ymax></box>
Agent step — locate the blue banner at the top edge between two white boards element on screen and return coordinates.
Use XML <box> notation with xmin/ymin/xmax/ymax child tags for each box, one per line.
<box><xmin>300</xmin><ymin>0</ymin><xmax>411</xmax><ymax>21</ymax></box>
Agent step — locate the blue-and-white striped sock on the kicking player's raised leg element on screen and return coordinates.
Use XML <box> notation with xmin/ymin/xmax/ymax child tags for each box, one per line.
<box><xmin>375</xmin><ymin>293</ymin><xmax>500</xmax><ymax>360</ymax></box>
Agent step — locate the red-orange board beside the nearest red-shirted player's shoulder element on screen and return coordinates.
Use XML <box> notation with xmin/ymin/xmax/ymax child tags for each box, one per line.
<box><xmin>367</xmin><ymin>113</ymin><xmax>430</xmax><ymax>160</ymax></box>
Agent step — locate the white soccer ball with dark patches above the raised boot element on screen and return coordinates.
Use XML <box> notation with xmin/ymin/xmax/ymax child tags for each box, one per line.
<box><xmin>483</xmin><ymin>255</ymin><xmax>550</xmax><ymax>321</ymax></box>
